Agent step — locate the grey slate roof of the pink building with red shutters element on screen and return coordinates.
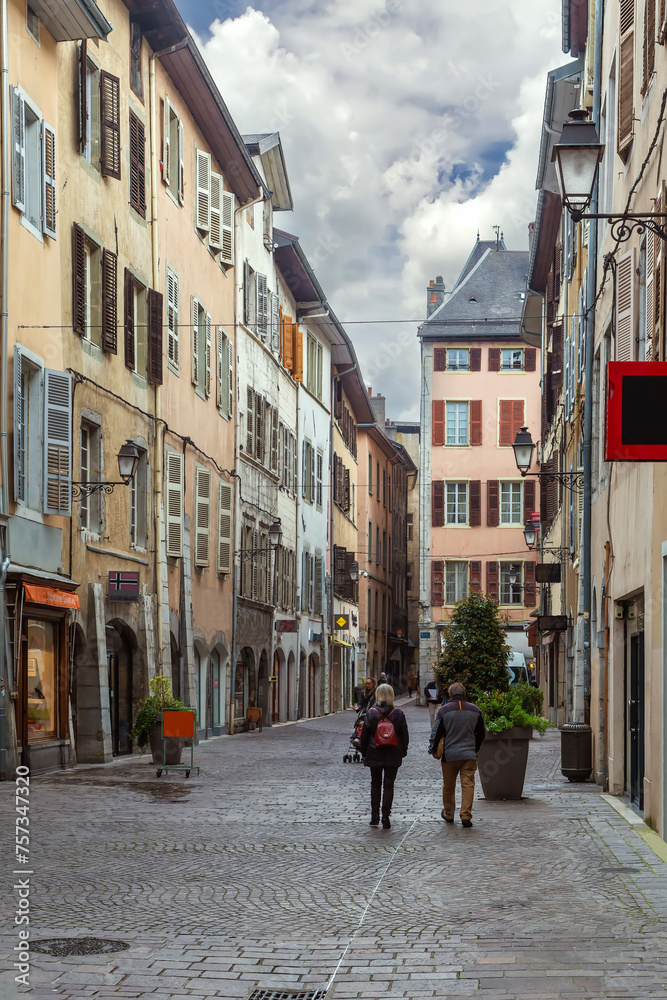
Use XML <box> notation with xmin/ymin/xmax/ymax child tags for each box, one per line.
<box><xmin>419</xmin><ymin>247</ymin><xmax>528</xmax><ymax>340</ymax></box>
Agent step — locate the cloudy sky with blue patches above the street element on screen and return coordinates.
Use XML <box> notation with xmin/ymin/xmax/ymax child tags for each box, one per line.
<box><xmin>177</xmin><ymin>0</ymin><xmax>569</xmax><ymax>419</ymax></box>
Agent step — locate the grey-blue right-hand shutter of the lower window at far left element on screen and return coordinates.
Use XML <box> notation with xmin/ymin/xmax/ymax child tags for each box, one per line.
<box><xmin>43</xmin><ymin>368</ymin><xmax>72</xmax><ymax>517</ymax></box>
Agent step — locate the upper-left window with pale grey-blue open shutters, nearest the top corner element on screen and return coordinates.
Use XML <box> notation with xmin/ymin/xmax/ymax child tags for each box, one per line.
<box><xmin>11</xmin><ymin>87</ymin><xmax>57</xmax><ymax>239</ymax></box>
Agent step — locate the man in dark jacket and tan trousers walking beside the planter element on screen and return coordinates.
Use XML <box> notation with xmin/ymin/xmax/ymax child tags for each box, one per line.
<box><xmin>428</xmin><ymin>681</ymin><xmax>486</xmax><ymax>826</ymax></box>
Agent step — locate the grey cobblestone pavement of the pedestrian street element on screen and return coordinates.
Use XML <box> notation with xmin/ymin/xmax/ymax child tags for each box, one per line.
<box><xmin>0</xmin><ymin>702</ymin><xmax>667</xmax><ymax>1000</ymax></box>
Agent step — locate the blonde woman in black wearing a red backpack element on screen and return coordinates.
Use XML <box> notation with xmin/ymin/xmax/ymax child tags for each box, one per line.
<box><xmin>361</xmin><ymin>684</ymin><xmax>410</xmax><ymax>830</ymax></box>
